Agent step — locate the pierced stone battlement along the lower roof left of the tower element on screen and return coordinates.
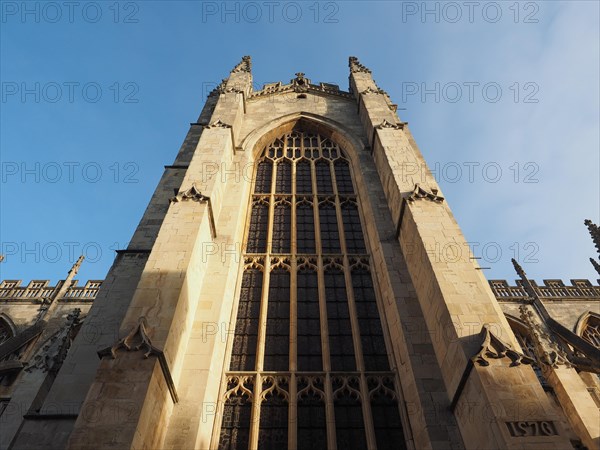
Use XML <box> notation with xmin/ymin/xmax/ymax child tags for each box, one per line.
<box><xmin>0</xmin><ymin>280</ymin><xmax>104</xmax><ymax>303</ymax></box>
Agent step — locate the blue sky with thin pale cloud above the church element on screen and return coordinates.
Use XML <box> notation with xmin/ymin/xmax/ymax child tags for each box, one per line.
<box><xmin>0</xmin><ymin>1</ymin><xmax>600</xmax><ymax>281</ymax></box>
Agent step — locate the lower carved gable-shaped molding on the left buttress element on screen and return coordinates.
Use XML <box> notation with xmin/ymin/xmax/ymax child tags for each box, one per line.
<box><xmin>98</xmin><ymin>316</ymin><xmax>179</xmax><ymax>403</ymax></box>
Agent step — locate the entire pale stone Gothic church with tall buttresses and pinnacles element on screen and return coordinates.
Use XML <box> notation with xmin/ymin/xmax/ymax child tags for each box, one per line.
<box><xmin>0</xmin><ymin>56</ymin><xmax>600</xmax><ymax>450</ymax></box>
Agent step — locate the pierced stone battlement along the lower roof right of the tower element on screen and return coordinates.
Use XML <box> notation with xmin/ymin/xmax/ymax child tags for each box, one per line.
<box><xmin>489</xmin><ymin>280</ymin><xmax>600</xmax><ymax>302</ymax></box>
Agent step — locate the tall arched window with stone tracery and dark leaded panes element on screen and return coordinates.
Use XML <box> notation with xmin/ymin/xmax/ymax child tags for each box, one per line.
<box><xmin>218</xmin><ymin>130</ymin><xmax>405</xmax><ymax>450</ymax></box>
